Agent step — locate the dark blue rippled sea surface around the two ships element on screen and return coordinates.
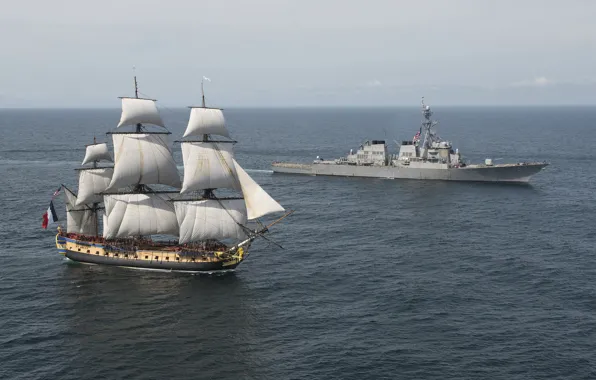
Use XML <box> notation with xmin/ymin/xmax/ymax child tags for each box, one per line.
<box><xmin>0</xmin><ymin>106</ymin><xmax>596</xmax><ymax>380</ymax></box>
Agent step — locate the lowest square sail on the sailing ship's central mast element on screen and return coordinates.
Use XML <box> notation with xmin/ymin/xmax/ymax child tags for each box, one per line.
<box><xmin>104</xmin><ymin>193</ymin><xmax>178</xmax><ymax>239</ymax></box>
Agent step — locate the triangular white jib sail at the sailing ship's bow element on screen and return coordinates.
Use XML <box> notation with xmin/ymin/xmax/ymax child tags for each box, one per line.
<box><xmin>234</xmin><ymin>160</ymin><xmax>285</xmax><ymax>220</ymax></box>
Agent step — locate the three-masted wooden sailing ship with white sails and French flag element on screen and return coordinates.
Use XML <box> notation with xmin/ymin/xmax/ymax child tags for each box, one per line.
<box><xmin>44</xmin><ymin>77</ymin><xmax>291</xmax><ymax>272</ymax></box>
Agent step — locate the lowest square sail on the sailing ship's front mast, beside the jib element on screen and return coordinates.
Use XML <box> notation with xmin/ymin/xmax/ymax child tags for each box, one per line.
<box><xmin>174</xmin><ymin>199</ymin><xmax>246</xmax><ymax>244</ymax></box>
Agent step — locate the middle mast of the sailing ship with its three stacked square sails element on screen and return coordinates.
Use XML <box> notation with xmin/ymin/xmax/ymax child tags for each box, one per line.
<box><xmin>102</xmin><ymin>75</ymin><xmax>180</xmax><ymax>239</ymax></box>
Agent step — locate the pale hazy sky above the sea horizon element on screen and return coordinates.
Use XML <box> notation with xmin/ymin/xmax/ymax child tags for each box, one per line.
<box><xmin>0</xmin><ymin>0</ymin><xmax>596</xmax><ymax>108</ymax></box>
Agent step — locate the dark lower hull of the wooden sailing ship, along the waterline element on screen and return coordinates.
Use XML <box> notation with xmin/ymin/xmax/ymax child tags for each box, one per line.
<box><xmin>65</xmin><ymin>250</ymin><xmax>240</xmax><ymax>272</ymax></box>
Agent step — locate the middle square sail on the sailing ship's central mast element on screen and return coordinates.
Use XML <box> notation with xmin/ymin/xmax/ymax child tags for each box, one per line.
<box><xmin>108</xmin><ymin>133</ymin><xmax>180</xmax><ymax>189</ymax></box>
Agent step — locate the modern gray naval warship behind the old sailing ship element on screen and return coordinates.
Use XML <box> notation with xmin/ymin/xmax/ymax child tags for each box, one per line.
<box><xmin>272</xmin><ymin>98</ymin><xmax>548</xmax><ymax>183</ymax></box>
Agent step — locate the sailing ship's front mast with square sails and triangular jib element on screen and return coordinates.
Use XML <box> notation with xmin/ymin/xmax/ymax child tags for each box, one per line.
<box><xmin>175</xmin><ymin>77</ymin><xmax>284</xmax><ymax>251</ymax></box>
